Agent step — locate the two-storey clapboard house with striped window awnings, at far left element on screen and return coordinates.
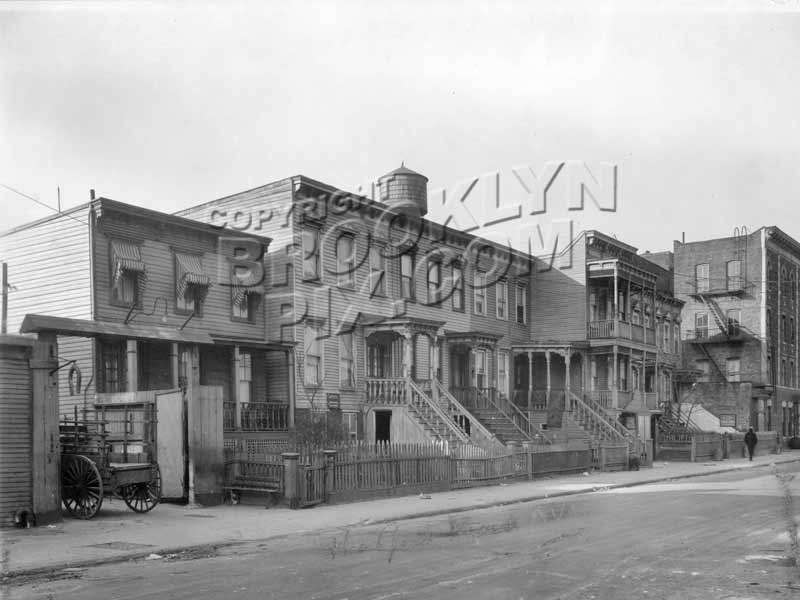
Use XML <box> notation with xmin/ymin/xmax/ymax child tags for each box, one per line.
<box><xmin>0</xmin><ymin>198</ymin><xmax>294</xmax><ymax>501</ymax></box>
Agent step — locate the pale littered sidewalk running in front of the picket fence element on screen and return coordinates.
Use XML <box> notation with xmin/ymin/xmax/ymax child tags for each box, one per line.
<box><xmin>0</xmin><ymin>451</ymin><xmax>800</xmax><ymax>577</ymax></box>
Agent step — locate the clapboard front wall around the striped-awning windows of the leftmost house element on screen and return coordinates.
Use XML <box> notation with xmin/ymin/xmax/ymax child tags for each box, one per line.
<box><xmin>94</xmin><ymin>213</ymin><xmax>268</xmax><ymax>339</ymax></box>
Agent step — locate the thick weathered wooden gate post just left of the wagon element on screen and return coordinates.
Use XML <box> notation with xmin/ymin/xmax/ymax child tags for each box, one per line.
<box><xmin>29</xmin><ymin>333</ymin><xmax>61</xmax><ymax>525</ymax></box>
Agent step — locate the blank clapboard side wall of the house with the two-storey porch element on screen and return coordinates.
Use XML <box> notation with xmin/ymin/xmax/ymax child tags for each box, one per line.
<box><xmin>531</xmin><ymin>233</ymin><xmax>586</xmax><ymax>341</ymax></box>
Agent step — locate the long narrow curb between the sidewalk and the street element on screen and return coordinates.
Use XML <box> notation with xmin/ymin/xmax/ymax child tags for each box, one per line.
<box><xmin>0</xmin><ymin>456</ymin><xmax>800</xmax><ymax>585</ymax></box>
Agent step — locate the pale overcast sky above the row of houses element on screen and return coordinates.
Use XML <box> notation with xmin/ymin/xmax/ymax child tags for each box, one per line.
<box><xmin>0</xmin><ymin>0</ymin><xmax>800</xmax><ymax>251</ymax></box>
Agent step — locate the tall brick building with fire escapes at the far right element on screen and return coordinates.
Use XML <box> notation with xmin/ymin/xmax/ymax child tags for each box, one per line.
<box><xmin>674</xmin><ymin>226</ymin><xmax>800</xmax><ymax>436</ymax></box>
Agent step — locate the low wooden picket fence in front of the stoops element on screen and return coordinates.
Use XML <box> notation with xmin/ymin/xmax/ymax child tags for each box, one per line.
<box><xmin>225</xmin><ymin>442</ymin><xmax>628</xmax><ymax>508</ymax></box>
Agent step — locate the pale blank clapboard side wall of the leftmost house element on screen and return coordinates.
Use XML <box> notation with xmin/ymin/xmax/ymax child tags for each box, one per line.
<box><xmin>0</xmin><ymin>206</ymin><xmax>92</xmax><ymax>333</ymax></box>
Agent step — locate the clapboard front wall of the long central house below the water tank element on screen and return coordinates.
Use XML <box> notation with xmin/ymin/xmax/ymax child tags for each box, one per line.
<box><xmin>284</xmin><ymin>191</ymin><xmax>531</xmax><ymax>410</ymax></box>
